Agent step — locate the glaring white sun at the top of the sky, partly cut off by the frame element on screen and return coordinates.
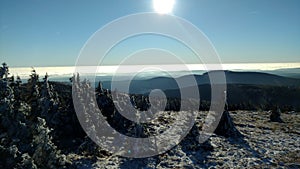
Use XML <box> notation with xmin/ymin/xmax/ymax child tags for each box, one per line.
<box><xmin>152</xmin><ymin>0</ymin><xmax>175</xmax><ymax>14</ymax></box>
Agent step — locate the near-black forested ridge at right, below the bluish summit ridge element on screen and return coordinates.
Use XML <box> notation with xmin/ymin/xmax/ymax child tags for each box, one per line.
<box><xmin>164</xmin><ymin>84</ymin><xmax>300</xmax><ymax>111</ymax></box>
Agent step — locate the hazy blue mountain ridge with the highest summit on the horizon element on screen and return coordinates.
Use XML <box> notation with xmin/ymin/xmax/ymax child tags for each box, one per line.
<box><xmin>102</xmin><ymin>71</ymin><xmax>300</xmax><ymax>94</ymax></box>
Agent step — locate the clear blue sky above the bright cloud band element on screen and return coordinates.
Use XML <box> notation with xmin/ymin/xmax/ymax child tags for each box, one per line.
<box><xmin>0</xmin><ymin>0</ymin><xmax>300</xmax><ymax>67</ymax></box>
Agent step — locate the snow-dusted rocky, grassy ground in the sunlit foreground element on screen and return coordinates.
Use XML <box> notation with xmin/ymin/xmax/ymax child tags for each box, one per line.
<box><xmin>68</xmin><ymin>111</ymin><xmax>300</xmax><ymax>169</ymax></box>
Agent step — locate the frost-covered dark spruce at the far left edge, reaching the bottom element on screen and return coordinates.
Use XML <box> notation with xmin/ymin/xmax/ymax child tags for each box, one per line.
<box><xmin>0</xmin><ymin>63</ymin><xmax>30</xmax><ymax>168</ymax></box>
